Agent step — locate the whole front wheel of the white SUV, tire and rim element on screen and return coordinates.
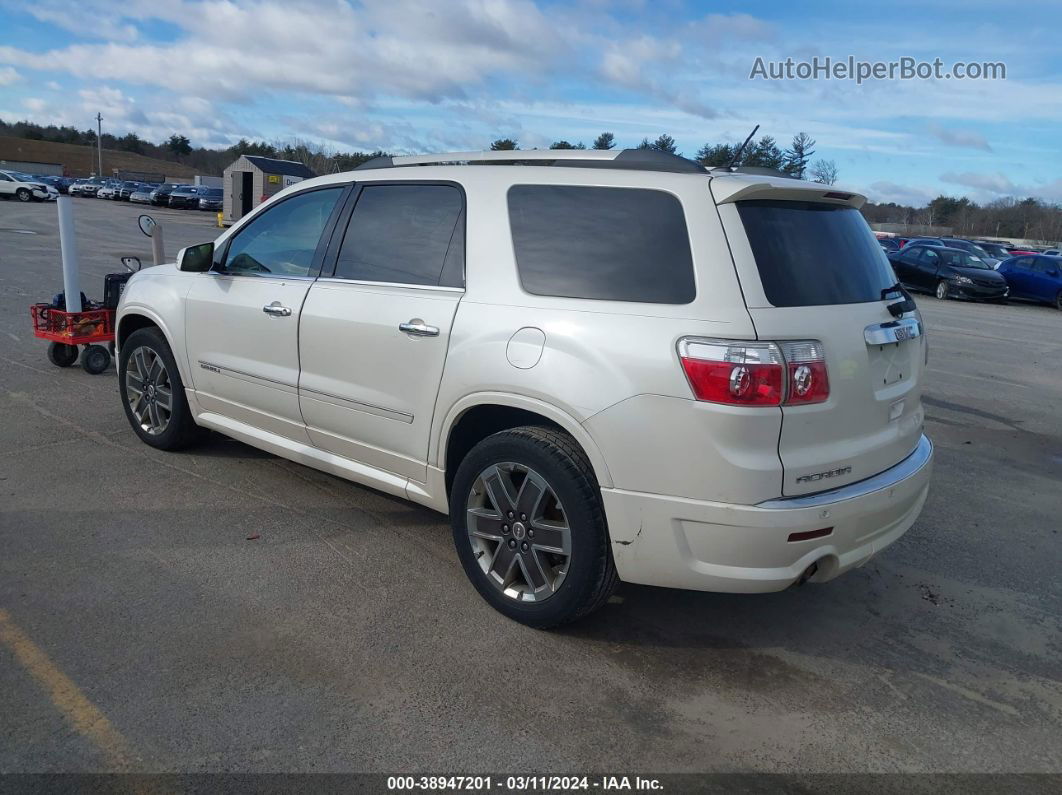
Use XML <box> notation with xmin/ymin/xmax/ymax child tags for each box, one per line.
<box><xmin>118</xmin><ymin>328</ymin><xmax>203</xmax><ymax>450</ymax></box>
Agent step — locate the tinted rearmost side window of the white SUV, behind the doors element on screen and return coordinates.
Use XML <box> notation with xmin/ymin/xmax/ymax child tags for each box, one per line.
<box><xmin>509</xmin><ymin>185</ymin><xmax>697</xmax><ymax>304</ymax></box>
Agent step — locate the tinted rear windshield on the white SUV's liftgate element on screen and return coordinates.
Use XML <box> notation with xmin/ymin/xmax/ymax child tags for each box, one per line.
<box><xmin>737</xmin><ymin>200</ymin><xmax>896</xmax><ymax>307</ymax></box>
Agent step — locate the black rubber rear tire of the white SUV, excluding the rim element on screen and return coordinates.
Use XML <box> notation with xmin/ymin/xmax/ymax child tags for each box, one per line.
<box><xmin>450</xmin><ymin>426</ymin><xmax>619</xmax><ymax>629</ymax></box>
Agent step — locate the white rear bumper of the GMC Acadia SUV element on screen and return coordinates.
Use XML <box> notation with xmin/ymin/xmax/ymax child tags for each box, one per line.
<box><xmin>601</xmin><ymin>436</ymin><xmax>932</xmax><ymax>593</ymax></box>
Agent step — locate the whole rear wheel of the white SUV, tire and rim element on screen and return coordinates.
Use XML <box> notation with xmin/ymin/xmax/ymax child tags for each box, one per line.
<box><xmin>450</xmin><ymin>426</ymin><xmax>618</xmax><ymax>629</ymax></box>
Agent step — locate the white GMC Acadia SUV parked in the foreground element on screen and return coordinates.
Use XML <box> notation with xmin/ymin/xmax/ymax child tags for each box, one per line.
<box><xmin>117</xmin><ymin>145</ymin><xmax>932</xmax><ymax>627</ymax></box>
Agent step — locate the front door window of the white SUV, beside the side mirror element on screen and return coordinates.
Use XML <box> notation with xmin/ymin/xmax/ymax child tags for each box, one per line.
<box><xmin>221</xmin><ymin>187</ymin><xmax>343</xmax><ymax>276</ymax></box>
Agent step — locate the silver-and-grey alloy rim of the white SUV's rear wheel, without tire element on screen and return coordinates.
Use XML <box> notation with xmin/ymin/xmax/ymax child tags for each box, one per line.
<box><xmin>466</xmin><ymin>463</ymin><xmax>571</xmax><ymax>602</ymax></box>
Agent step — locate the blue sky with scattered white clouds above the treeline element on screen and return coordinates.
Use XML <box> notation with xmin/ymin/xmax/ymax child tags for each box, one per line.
<box><xmin>0</xmin><ymin>0</ymin><xmax>1062</xmax><ymax>204</ymax></box>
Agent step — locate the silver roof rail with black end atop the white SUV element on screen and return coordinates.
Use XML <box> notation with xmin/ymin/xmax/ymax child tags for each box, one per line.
<box><xmin>355</xmin><ymin>149</ymin><xmax>707</xmax><ymax>174</ymax></box>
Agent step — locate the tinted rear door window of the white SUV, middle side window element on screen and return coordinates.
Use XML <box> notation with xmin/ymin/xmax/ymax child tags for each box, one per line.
<box><xmin>336</xmin><ymin>184</ymin><xmax>464</xmax><ymax>287</ymax></box>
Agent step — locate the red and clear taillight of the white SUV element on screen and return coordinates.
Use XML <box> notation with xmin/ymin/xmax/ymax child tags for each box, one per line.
<box><xmin>679</xmin><ymin>336</ymin><xmax>829</xmax><ymax>405</ymax></box>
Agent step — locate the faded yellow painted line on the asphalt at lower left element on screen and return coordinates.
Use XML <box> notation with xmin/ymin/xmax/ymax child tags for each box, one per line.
<box><xmin>0</xmin><ymin>609</ymin><xmax>132</xmax><ymax>772</ymax></box>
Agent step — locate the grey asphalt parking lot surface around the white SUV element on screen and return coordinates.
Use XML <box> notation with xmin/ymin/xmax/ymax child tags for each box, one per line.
<box><xmin>0</xmin><ymin>200</ymin><xmax>1062</xmax><ymax>773</ymax></box>
